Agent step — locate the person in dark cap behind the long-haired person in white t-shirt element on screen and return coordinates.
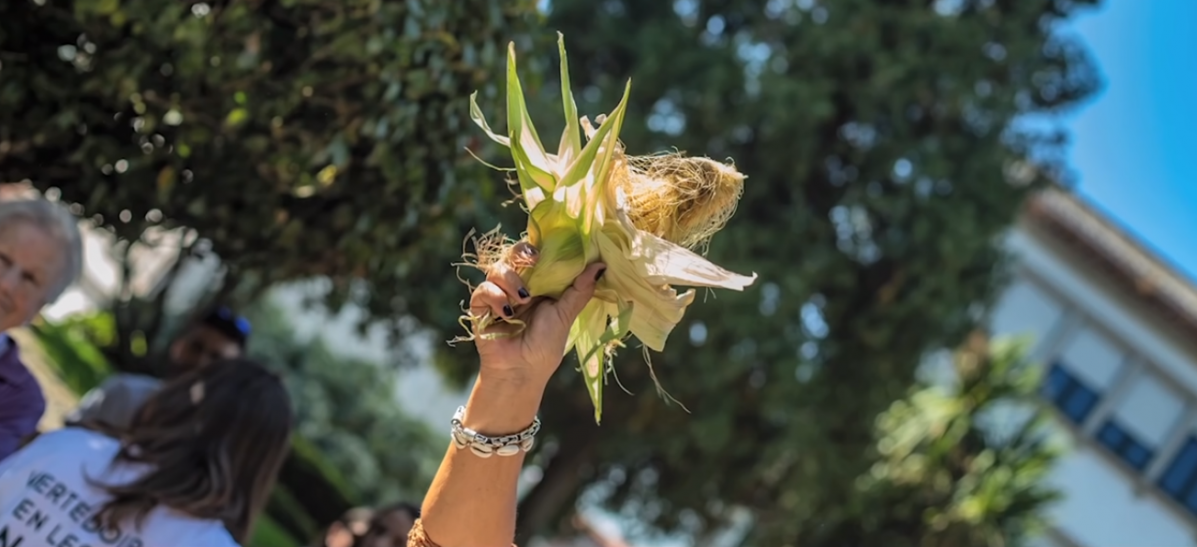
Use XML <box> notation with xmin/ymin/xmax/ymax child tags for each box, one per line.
<box><xmin>66</xmin><ymin>306</ymin><xmax>250</xmax><ymax>427</ymax></box>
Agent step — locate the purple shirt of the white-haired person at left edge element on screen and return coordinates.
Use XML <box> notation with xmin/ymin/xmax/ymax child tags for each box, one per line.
<box><xmin>0</xmin><ymin>334</ymin><xmax>45</xmax><ymax>460</ymax></box>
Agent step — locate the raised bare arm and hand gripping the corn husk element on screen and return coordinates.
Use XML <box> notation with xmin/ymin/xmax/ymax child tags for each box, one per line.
<box><xmin>408</xmin><ymin>251</ymin><xmax>604</xmax><ymax>547</ymax></box>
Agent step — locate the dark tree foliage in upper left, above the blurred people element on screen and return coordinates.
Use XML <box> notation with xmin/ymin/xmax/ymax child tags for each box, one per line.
<box><xmin>0</xmin><ymin>0</ymin><xmax>534</xmax><ymax>321</ymax></box>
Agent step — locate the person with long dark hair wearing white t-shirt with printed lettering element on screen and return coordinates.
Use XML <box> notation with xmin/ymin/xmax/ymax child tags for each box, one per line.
<box><xmin>0</xmin><ymin>360</ymin><xmax>294</xmax><ymax>547</ymax></box>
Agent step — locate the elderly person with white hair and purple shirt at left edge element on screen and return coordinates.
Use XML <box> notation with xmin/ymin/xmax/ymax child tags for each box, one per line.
<box><xmin>0</xmin><ymin>199</ymin><xmax>83</xmax><ymax>460</ymax></box>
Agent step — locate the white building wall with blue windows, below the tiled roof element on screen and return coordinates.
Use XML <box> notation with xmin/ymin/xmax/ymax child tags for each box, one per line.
<box><xmin>990</xmin><ymin>229</ymin><xmax>1197</xmax><ymax>547</ymax></box>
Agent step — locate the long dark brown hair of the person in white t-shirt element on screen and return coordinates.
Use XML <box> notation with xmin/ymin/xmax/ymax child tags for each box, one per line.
<box><xmin>89</xmin><ymin>359</ymin><xmax>293</xmax><ymax>542</ymax></box>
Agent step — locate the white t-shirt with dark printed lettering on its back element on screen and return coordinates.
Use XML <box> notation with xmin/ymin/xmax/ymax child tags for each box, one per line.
<box><xmin>0</xmin><ymin>427</ymin><xmax>238</xmax><ymax>547</ymax></box>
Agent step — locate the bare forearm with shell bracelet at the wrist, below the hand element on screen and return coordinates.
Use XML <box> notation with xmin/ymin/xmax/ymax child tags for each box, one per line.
<box><xmin>421</xmin><ymin>376</ymin><xmax>543</xmax><ymax>547</ymax></box>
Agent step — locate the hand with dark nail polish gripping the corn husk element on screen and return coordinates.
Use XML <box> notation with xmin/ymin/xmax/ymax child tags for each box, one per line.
<box><xmin>469</xmin><ymin>243</ymin><xmax>607</xmax><ymax>388</ymax></box>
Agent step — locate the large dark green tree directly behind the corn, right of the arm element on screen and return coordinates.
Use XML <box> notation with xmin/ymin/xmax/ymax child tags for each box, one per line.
<box><xmin>497</xmin><ymin>0</ymin><xmax>1098</xmax><ymax>546</ymax></box>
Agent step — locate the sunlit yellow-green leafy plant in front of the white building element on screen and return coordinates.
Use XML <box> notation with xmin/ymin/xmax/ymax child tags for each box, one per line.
<box><xmin>799</xmin><ymin>336</ymin><xmax>1059</xmax><ymax>547</ymax></box>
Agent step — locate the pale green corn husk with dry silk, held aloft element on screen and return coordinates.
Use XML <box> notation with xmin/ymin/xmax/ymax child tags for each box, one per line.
<box><xmin>467</xmin><ymin>36</ymin><xmax>757</xmax><ymax>423</ymax></box>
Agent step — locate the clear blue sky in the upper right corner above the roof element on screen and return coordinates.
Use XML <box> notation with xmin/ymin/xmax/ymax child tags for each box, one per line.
<box><xmin>1065</xmin><ymin>0</ymin><xmax>1197</xmax><ymax>278</ymax></box>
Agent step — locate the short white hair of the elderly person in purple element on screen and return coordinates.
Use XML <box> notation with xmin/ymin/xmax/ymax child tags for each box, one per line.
<box><xmin>0</xmin><ymin>197</ymin><xmax>83</xmax><ymax>303</ymax></box>
